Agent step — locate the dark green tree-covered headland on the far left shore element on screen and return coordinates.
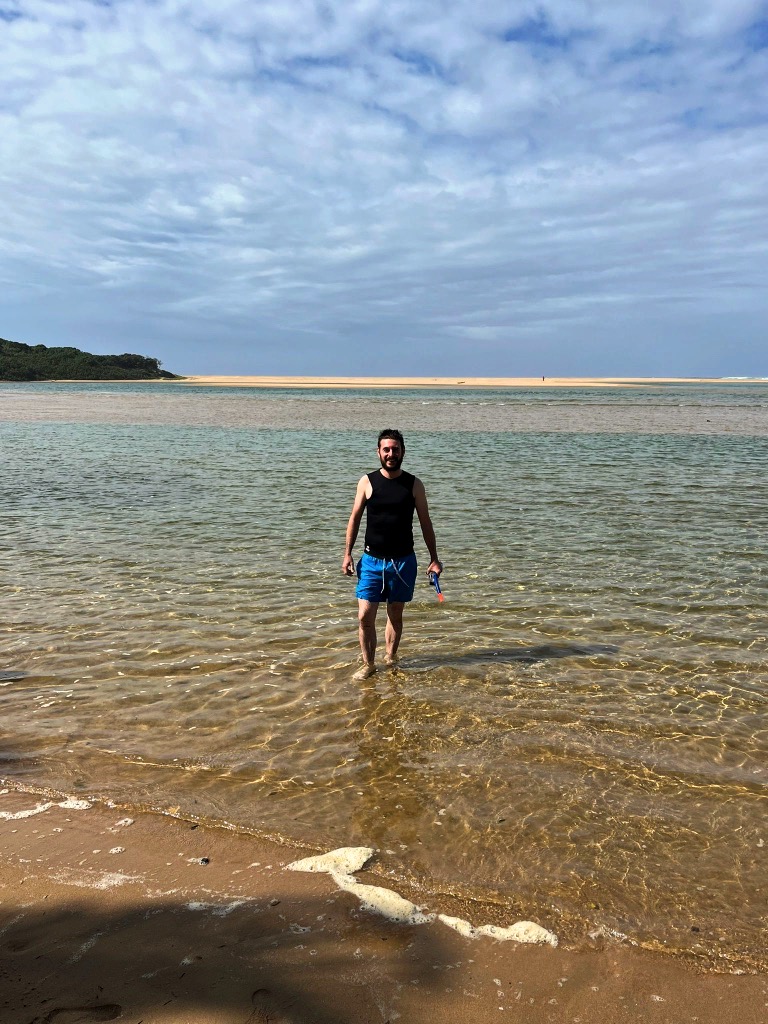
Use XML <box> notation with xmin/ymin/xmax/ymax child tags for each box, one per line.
<box><xmin>0</xmin><ymin>338</ymin><xmax>179</xmax><ymax>381</ymax></box>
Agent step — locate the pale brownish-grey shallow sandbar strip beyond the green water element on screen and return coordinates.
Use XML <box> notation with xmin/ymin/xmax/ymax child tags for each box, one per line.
<box><xmin>7</xmin><ymin>378</ymin><xmax>768</xmax><ymax>437</ymax></box>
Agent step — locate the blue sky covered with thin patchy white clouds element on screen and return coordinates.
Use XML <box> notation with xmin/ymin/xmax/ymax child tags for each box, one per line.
<box><xmin>0</xmin><ymin>0</ymin><xmax>768</xmax><ymax>376</ymax></box>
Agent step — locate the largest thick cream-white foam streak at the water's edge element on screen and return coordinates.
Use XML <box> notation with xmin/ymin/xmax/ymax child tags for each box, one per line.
<box><xmin>287</xmin><ymin>846</ymin><xmax>557</xmax><ymax>946</ymax></box>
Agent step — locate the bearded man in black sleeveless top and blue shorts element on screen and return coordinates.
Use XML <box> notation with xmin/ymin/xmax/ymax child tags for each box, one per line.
<box><xmin>341</xmin><ymin>430</ymin><xmax>442</xmax><ymax>679</ymax></box>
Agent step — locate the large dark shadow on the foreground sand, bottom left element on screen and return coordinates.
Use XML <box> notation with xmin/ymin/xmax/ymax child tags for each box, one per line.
<box><xmin>0</xmin><ymin>889</ymin><xmax>456</xmax><ymax>1024</ymax></box>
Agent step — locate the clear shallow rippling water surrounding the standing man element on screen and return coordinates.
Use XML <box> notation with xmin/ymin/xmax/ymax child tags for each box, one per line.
<box><xmin>0</xmin><ymin>385</ymin><xmax>768</xmax><ymax>970</ymax></box>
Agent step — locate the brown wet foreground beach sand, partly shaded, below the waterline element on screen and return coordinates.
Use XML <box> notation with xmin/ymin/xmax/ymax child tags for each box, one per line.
<box><xmin>0</xmin><ymin>792</ymin><xmax>768</xmax><ymax>1024</ymax></box>
